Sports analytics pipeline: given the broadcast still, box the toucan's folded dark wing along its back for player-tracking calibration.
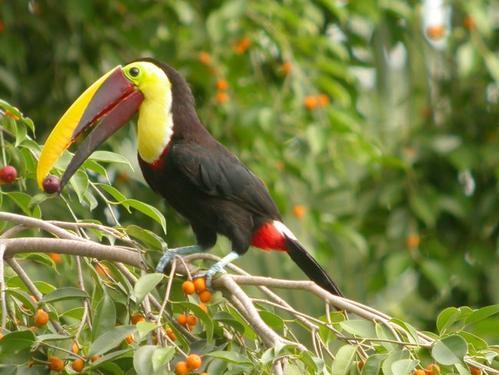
[168,142,279,219]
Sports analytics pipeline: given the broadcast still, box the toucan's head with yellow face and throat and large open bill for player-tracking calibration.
[37,59,189,189]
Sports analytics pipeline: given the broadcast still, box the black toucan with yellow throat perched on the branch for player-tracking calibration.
[37,58,342,296]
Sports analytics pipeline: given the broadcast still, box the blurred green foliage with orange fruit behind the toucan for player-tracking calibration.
[0,0,499,339]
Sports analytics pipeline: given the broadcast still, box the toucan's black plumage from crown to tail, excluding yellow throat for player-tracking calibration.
[139,59,341,295]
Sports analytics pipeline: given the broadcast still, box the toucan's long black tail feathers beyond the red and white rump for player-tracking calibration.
[286,236,343,297]
